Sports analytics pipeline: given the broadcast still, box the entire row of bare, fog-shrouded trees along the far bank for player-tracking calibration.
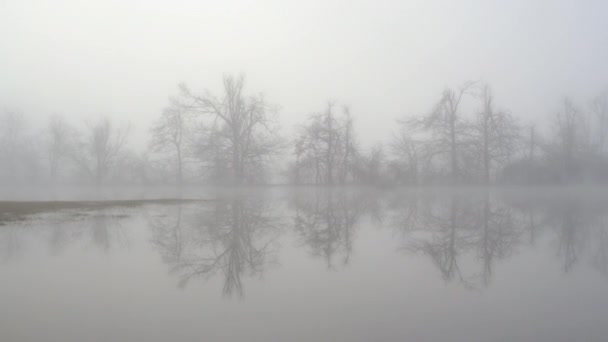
[0,75,608,186]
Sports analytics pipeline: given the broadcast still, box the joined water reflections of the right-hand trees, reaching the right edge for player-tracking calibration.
[389,192,608,289]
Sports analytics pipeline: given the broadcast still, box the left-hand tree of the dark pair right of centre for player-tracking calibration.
[409,82,473,182]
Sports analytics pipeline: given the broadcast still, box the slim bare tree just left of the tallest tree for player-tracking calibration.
[150,99,191,185]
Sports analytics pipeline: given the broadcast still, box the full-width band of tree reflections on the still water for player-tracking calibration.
[0,189,608,296]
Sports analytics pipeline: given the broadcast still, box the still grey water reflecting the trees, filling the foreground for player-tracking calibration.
[0,189,608,341]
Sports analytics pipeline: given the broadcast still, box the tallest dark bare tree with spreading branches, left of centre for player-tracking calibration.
[180,75,282,184]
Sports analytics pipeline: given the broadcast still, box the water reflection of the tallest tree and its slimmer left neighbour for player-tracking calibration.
[151,198,280,296]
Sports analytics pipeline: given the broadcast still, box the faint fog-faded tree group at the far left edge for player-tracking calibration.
[0,110,134,185]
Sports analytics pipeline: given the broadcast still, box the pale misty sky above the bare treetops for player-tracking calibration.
[0,0,608,146]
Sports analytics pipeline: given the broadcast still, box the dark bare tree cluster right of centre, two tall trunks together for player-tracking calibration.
[389,83,519,184]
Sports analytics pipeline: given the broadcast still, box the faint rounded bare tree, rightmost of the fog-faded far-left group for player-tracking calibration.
[73,117,130,184]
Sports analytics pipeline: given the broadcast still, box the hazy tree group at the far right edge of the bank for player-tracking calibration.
[502,92,608,184]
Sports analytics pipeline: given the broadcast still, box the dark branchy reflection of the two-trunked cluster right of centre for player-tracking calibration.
[405,196,520,289]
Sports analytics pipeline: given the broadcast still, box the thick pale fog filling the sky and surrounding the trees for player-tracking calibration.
[0,1,608,184]
